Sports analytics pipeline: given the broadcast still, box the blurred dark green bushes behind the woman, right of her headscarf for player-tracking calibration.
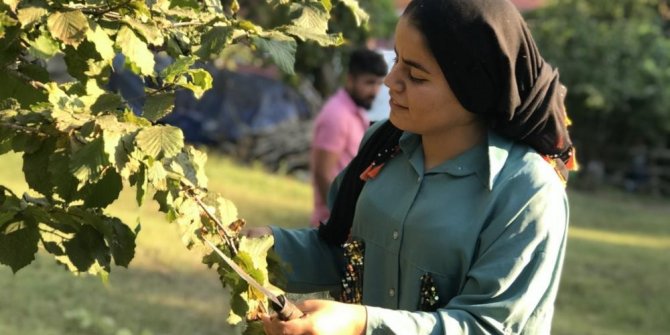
[528,0,670,158]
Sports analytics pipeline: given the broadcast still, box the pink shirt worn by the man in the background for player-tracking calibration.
[310,89,370,227]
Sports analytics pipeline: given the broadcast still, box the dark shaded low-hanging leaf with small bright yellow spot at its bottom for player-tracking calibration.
[63,225,111,272]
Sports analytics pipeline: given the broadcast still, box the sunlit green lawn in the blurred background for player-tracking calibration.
[0,155,670,335]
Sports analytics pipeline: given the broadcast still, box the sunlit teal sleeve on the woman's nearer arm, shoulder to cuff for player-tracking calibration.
[366,180,568,335]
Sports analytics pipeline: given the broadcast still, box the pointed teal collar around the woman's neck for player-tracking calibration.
[399,131,514,190]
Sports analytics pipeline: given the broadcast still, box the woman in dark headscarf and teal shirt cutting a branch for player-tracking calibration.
[252,0,573,334]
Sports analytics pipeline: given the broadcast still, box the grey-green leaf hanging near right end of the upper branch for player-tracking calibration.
[252,32,297,74]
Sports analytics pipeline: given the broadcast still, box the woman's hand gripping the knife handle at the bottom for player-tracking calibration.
[261,300,367,335]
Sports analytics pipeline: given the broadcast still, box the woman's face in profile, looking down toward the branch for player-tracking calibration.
[384,17,478,136]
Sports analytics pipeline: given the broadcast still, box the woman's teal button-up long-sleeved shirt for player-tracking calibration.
[273,124,568,334]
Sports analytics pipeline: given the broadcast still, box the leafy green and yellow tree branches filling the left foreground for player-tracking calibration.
[0,0,365,332]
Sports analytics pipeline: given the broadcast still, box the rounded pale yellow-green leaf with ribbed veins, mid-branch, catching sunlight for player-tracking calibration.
[135,125,184,159]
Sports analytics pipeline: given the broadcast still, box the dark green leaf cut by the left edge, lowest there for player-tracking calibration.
[0,220,40,273]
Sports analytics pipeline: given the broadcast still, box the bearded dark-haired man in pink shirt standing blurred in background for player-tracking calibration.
[310,49,387,227]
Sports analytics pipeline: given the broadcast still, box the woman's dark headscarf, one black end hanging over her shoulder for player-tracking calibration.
[319,0,576,245]
